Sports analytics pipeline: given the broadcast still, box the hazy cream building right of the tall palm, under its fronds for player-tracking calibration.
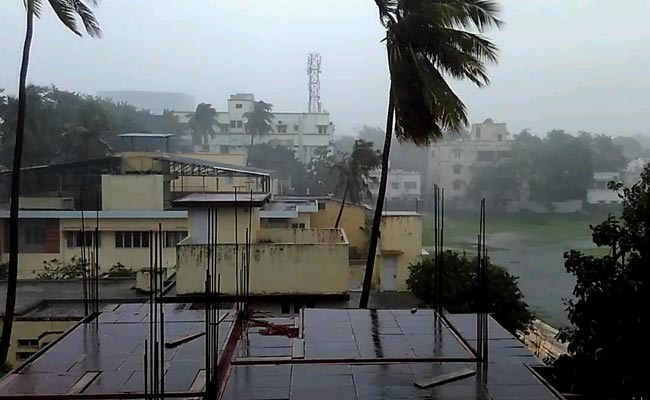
[429,119,513,206]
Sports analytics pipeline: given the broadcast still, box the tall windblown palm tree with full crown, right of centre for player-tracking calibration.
[359,0,501,307]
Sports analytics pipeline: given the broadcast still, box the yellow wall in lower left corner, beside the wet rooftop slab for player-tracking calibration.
[0,319,77,368]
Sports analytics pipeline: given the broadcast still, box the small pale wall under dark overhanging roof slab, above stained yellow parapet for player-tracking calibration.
[188,207,260,244]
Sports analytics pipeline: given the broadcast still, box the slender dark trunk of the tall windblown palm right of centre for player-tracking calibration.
[359,85,395,308]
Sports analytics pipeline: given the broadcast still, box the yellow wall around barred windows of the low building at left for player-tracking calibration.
[0,216,188,279]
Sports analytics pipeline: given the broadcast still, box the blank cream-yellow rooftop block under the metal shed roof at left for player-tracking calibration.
[102,175,165,211]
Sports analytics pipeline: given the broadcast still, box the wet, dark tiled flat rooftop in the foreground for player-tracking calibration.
[0,303,558,400]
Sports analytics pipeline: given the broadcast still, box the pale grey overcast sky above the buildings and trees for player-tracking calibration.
[0,0,650,135]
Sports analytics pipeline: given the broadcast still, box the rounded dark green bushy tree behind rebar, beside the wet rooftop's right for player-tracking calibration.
[406,250,534,335]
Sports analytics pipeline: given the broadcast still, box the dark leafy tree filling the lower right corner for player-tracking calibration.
[553,166,650,399]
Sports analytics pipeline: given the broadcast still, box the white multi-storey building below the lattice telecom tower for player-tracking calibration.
[175,93,334,163]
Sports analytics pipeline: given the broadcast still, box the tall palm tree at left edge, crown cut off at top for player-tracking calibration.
[0,0,101,365]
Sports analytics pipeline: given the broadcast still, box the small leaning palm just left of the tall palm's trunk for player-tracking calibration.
[334,139,381,228]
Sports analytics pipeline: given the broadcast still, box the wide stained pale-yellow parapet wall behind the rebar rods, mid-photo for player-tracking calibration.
[176,244,349,295]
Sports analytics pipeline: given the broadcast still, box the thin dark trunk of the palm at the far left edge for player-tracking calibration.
[0,0,34,367]
